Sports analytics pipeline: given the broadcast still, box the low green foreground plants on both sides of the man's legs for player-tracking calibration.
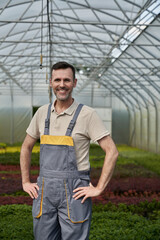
[0,201,160,240]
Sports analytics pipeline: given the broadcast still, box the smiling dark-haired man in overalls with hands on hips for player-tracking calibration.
[20,62,118,240]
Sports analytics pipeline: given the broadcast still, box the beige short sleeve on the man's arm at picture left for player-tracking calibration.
[26,110,40,139]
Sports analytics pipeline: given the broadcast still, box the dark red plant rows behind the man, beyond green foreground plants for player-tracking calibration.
[0,165,160,205]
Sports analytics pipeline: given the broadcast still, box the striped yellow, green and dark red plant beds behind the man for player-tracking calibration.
[0,145,160,205]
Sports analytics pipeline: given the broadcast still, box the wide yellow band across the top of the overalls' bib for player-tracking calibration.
[41,135,74,146]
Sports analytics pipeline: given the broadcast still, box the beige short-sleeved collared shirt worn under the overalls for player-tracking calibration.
[26,101,109,170]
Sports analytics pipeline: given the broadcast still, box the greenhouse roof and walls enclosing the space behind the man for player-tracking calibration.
[0,0,160,153]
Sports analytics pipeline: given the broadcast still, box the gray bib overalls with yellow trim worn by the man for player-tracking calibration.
[32,104,92,240]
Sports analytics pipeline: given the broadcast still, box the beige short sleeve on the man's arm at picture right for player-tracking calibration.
[88,110,110,142]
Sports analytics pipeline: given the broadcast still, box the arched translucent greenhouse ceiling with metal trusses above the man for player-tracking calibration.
[0,0,160,108]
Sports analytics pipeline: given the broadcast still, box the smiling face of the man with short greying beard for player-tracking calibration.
[50,68,77,101]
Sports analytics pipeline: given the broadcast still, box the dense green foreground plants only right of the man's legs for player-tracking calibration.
[90,207,160,240]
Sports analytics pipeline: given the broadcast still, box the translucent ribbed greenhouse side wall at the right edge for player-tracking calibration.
[130,103,160,153]
